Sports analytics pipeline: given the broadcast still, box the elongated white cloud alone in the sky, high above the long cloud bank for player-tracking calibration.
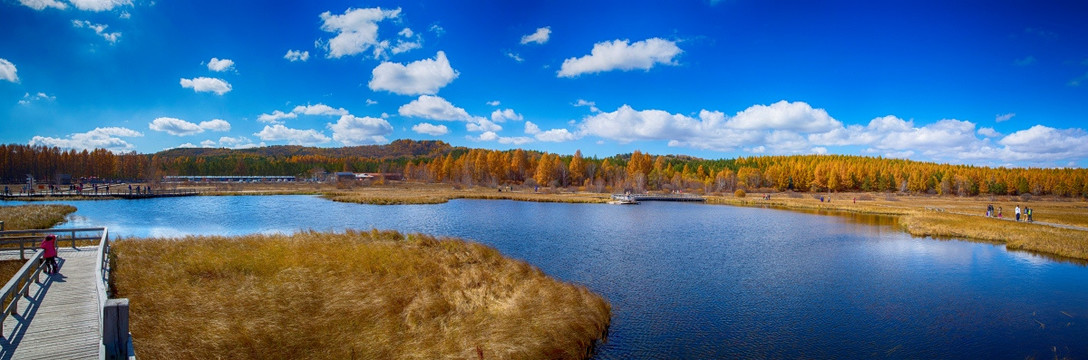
[558,37,682,77]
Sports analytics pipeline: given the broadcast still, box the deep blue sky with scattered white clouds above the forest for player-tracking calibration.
[0,0,1088,167]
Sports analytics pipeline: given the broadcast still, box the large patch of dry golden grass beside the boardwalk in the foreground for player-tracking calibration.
[111,231,611,359]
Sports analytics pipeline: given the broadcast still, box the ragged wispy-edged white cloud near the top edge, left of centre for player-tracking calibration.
[321,8,400,59]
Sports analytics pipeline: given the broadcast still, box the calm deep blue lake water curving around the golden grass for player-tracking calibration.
[4,196,1088,359]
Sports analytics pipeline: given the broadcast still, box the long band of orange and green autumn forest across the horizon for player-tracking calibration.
[0,140,1088,198]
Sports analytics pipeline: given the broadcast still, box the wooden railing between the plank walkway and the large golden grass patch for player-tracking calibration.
[95,227,136,360]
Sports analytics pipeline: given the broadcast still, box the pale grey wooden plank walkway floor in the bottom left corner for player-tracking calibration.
[0,246,101,359]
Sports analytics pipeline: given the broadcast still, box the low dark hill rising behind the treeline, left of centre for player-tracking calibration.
[154,139,454,160]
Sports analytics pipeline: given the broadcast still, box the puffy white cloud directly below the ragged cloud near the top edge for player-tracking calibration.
[368,51,459,95]
